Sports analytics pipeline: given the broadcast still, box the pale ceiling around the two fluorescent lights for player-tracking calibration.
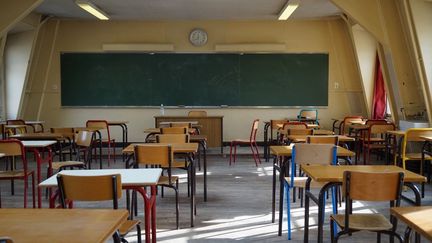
[35,0,341,20]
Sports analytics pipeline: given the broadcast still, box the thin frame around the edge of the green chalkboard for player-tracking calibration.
[60,51,330,109]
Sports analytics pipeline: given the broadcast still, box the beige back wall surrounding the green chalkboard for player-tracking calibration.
[23,19,366,141]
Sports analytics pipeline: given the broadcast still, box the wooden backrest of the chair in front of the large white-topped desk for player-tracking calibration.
[57,174,122,204]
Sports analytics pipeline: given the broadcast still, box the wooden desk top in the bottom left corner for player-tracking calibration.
[0,208,129,243]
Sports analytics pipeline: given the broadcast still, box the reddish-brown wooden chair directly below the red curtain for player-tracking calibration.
[361,122,396,164]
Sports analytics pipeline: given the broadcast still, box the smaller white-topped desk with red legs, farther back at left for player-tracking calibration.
[22,140,57,208]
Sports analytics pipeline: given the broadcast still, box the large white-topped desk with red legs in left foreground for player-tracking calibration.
[39,169,162,243]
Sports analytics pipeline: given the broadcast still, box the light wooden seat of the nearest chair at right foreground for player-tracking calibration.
[331,214,393,231]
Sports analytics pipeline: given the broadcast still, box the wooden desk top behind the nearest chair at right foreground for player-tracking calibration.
[301,164,426,182]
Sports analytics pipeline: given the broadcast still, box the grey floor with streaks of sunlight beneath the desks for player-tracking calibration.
[0,145,432,242]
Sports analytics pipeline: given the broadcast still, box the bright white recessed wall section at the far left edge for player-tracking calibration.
[5,31,34,119]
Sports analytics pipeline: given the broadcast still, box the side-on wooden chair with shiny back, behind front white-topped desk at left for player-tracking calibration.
[52,131,93,171]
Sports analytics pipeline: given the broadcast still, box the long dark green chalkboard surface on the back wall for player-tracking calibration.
[60,53,328,107]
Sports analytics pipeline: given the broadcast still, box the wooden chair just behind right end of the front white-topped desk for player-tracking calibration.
[134,144,179,229]
